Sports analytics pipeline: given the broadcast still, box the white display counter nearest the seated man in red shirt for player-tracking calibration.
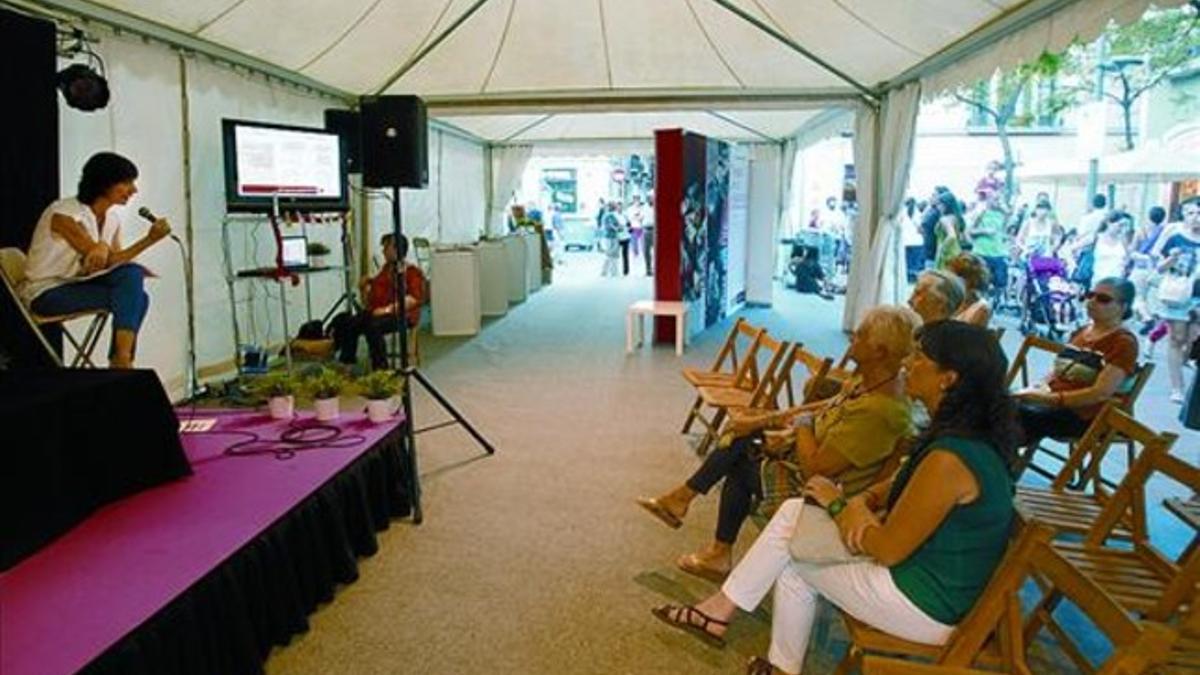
[430,247,482,335]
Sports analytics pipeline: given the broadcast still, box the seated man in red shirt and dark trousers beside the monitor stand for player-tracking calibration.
[334,234,425,370]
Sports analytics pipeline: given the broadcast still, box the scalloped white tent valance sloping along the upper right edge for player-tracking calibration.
[922,0,1156,98]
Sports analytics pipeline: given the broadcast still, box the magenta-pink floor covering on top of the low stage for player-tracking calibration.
[0,410,396,675]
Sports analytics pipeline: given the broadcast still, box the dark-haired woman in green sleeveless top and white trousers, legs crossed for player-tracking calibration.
[654,321,1018,675]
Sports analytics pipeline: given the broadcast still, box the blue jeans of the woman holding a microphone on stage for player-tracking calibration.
[30,264,150,333]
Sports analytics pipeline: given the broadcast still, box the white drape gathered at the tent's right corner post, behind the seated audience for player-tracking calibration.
[842,83,920,330]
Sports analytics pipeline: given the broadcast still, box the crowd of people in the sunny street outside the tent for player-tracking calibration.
[901,183,1200,404]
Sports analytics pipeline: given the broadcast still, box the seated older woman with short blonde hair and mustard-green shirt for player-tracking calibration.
[638,306,920,580]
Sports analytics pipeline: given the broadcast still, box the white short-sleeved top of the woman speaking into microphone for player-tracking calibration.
[20,197,121,303]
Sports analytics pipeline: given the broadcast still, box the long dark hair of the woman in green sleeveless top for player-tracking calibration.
[916,321,1020,468]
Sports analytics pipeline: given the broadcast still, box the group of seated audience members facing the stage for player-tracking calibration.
[637,237,1185,675]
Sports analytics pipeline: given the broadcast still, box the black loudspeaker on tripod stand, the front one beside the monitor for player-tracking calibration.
[360,96,430,187]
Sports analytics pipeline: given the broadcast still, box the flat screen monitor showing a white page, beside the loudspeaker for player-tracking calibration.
[221,119,349,211]
